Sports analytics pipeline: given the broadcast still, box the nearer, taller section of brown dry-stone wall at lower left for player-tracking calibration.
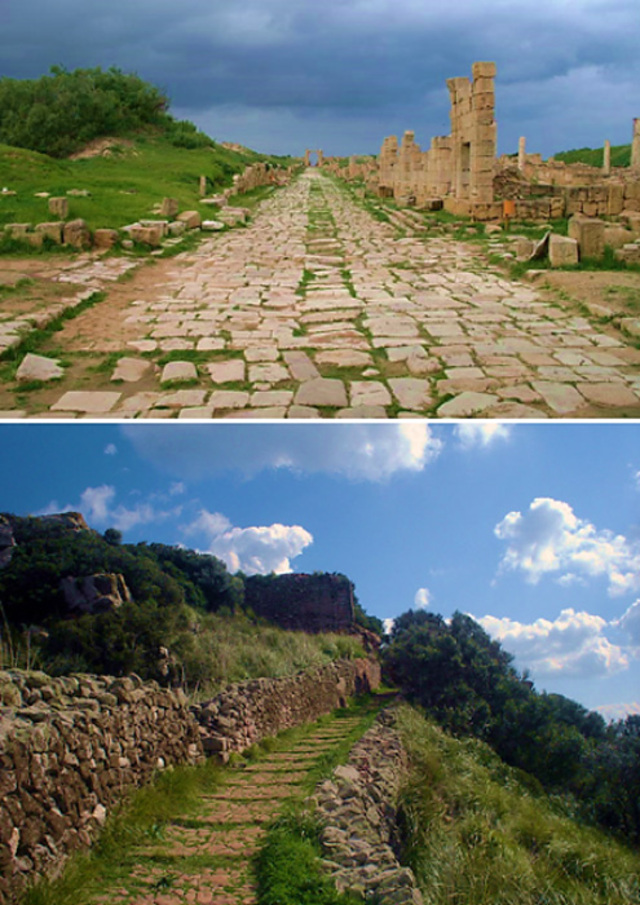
[0,670,203,903]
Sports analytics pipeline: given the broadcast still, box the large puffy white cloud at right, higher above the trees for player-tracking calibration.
[494,497,640,595]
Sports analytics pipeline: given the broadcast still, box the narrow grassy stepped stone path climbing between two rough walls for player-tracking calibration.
[87,716,361,905]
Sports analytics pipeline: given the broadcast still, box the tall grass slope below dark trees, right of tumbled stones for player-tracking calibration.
[399,707,640,905]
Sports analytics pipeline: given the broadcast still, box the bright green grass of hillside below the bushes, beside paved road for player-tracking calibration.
[0,133,292,229]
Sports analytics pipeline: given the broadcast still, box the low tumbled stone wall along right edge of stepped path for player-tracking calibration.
[315,710,423,905]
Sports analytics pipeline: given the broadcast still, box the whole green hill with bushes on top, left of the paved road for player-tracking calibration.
[0,67,290,237]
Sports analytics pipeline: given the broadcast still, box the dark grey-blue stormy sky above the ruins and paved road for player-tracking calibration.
[0,0,640,157]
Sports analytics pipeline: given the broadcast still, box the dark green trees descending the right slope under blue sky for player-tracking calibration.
[383,611,640,844]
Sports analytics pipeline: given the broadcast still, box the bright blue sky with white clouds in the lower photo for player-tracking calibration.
[0,422,640,716]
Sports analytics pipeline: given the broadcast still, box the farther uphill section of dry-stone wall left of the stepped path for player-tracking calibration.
[193,659,380,762]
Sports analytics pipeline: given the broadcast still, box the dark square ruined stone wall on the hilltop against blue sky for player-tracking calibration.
[245,573,355,633]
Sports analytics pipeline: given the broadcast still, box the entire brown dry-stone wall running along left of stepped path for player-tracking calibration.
[0,659,380,905]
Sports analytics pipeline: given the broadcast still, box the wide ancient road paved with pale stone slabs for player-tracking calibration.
[5,170,640,419]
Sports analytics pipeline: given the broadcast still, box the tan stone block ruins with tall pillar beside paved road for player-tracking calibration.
[332,62,640,221]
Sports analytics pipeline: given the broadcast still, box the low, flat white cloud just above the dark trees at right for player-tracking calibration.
[477,609,629,678]
